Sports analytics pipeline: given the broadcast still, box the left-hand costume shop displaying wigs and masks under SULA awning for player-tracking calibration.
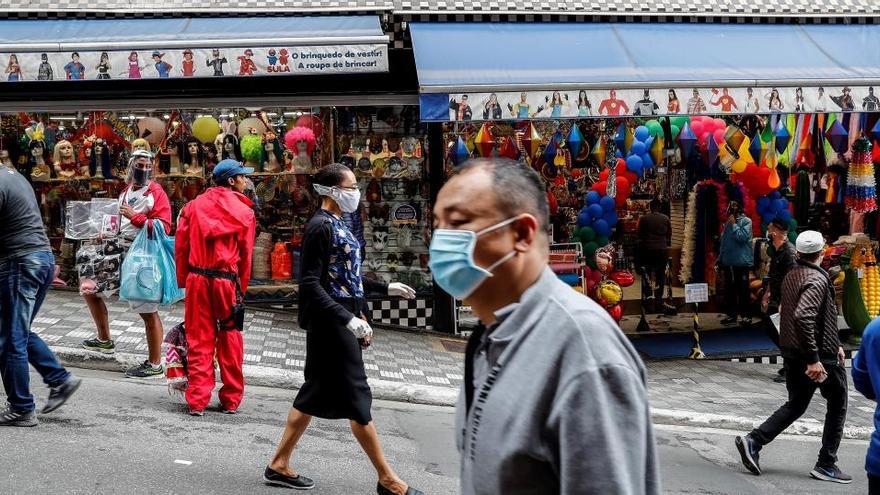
[0,15,432,329]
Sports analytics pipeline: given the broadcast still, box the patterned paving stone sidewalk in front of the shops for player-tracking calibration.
[34,291,874,438]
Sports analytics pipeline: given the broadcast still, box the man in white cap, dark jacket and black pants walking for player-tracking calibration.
[735,230,852,484]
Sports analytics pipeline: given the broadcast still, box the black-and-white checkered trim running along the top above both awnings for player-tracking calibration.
[0,0,880,22]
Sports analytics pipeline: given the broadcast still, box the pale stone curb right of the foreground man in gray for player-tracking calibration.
[651,409,874,440]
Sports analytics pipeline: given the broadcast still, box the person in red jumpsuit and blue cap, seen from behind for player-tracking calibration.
[175,159,256,416]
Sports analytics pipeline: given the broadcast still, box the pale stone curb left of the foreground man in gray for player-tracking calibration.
[51,346,458,406]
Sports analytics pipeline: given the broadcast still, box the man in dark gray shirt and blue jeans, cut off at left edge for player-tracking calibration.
[0,167,82,426]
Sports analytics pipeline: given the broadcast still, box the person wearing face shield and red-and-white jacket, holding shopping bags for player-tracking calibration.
[82,150,171,378]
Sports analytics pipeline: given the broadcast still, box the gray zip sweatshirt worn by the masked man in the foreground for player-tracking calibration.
[456,268,660,495]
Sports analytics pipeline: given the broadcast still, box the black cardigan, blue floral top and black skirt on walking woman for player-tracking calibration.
[293,210,388,425]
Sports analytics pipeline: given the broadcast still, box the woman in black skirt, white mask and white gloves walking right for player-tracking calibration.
[263,163,422,495]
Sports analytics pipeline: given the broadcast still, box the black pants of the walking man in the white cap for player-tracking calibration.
[750,359,847,466]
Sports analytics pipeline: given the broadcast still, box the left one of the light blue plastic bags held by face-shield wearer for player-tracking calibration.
[119,224,163,303]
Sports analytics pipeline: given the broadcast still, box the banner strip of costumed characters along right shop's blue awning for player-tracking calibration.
[438,86,880,122]
